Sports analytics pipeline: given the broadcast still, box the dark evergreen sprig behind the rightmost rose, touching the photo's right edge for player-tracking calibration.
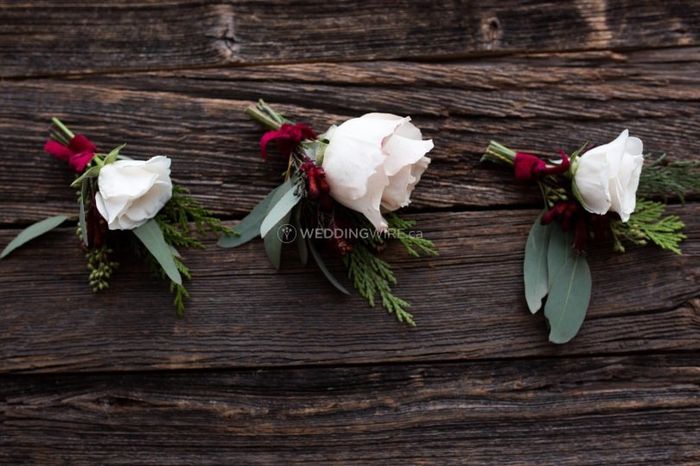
[637,154,700,202]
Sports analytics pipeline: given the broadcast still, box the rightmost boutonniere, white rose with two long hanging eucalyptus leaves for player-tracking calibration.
[482,130,700,343]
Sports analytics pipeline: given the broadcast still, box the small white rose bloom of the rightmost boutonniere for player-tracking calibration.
[574,130,644,222]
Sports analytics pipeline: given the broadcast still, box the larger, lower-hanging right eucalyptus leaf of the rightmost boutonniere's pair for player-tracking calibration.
[544,228,591,343]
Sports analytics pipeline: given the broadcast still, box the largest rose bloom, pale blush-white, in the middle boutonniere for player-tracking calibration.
[323,113,433,231]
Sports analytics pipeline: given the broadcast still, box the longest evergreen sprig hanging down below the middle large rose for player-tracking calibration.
[343,243,416,326]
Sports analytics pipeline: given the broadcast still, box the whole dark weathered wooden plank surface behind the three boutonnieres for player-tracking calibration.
[0,0,700,465]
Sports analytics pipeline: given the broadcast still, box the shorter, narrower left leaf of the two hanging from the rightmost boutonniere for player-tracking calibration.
[523,215,554,314]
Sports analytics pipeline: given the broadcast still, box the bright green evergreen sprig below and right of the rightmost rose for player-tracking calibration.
[610,200,686,255]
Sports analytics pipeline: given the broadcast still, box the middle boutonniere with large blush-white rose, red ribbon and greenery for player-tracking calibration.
[219,100,437,325]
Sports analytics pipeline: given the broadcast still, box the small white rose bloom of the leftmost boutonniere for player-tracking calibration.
[95,155,173,230]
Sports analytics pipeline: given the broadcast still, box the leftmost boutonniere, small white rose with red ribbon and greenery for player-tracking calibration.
[0,118,232,315]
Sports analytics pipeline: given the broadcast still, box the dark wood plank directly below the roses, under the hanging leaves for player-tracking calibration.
[0,204,700,372]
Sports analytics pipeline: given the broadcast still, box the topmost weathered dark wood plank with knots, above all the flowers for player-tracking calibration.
[0,0,700,77]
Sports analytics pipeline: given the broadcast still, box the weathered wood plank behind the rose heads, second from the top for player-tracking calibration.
[0,49,700,223]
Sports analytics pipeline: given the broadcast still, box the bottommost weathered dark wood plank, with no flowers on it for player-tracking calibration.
[0,354,700,466]
